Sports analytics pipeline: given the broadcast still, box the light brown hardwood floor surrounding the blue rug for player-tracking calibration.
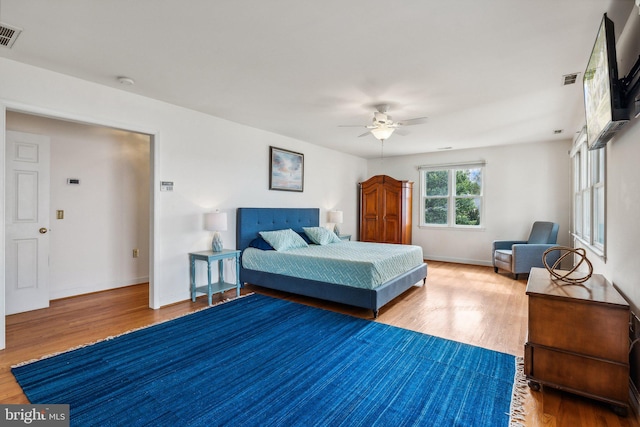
[0,261,640,427]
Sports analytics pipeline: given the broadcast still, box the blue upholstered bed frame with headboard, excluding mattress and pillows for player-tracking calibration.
[236,208,427,318]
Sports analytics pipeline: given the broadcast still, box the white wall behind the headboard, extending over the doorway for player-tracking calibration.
[0,58,367,344]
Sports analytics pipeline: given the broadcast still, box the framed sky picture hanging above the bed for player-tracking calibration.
[269,147,304,192]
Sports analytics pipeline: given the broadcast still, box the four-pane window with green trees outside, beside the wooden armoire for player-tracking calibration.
[419,163,484,228]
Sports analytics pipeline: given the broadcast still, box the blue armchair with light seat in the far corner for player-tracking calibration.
[492,221,560,280]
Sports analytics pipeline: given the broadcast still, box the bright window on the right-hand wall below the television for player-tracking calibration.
[571,133,606,256]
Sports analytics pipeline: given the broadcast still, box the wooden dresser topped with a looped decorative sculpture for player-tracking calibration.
[524,268,629,415]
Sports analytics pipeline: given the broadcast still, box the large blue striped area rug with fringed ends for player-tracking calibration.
[12,294,516,427]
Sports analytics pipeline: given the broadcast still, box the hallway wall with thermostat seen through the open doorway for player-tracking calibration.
[7,112,150,299]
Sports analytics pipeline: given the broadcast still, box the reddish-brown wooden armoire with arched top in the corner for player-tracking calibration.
[359,175,413,245]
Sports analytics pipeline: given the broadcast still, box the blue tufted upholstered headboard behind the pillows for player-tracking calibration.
[236,208,320,250]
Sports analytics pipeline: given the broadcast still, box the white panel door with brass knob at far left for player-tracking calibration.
[5,131,49,314]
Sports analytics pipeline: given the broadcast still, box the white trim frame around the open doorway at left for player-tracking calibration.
[0,99,160,350]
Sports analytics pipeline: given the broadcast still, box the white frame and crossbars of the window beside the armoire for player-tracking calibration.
[418,161,486,230]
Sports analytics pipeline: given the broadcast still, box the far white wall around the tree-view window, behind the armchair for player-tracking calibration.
[369,140,571,265]
